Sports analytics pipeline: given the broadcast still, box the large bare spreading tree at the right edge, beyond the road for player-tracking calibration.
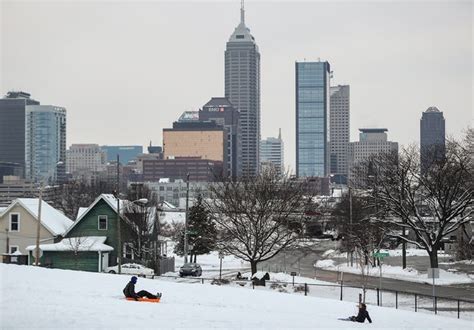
[361,142,474,268]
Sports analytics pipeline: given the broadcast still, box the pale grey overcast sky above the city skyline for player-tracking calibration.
[0,0,474,169]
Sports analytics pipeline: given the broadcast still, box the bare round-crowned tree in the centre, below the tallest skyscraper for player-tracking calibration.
[204,168,311,274]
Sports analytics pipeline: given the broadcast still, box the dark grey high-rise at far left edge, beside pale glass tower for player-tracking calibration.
[0,92,40,177]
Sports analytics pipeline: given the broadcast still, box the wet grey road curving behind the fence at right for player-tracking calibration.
[258,240,474,301]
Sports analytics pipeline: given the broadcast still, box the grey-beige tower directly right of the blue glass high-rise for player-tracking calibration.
[329,85,350,184]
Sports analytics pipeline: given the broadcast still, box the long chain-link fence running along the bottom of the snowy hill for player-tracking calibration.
[153,276,474,320]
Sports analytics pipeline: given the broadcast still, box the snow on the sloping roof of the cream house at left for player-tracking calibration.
[5,198,74,235]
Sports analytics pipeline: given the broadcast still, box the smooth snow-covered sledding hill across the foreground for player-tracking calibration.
[0,264,472,329]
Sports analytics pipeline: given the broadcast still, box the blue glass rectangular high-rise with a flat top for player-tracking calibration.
[295,61,331,177]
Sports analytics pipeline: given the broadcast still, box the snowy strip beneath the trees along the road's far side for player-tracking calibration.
[314,259,474,285]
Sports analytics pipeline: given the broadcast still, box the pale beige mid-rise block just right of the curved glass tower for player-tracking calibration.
[66,144,107,177]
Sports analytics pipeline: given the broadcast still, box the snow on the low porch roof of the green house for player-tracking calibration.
[26,236,114,252]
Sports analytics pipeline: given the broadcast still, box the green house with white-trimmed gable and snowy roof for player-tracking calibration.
[27,194,141,272]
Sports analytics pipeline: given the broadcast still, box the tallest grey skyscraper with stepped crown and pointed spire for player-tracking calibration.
[225,0,260,176]
